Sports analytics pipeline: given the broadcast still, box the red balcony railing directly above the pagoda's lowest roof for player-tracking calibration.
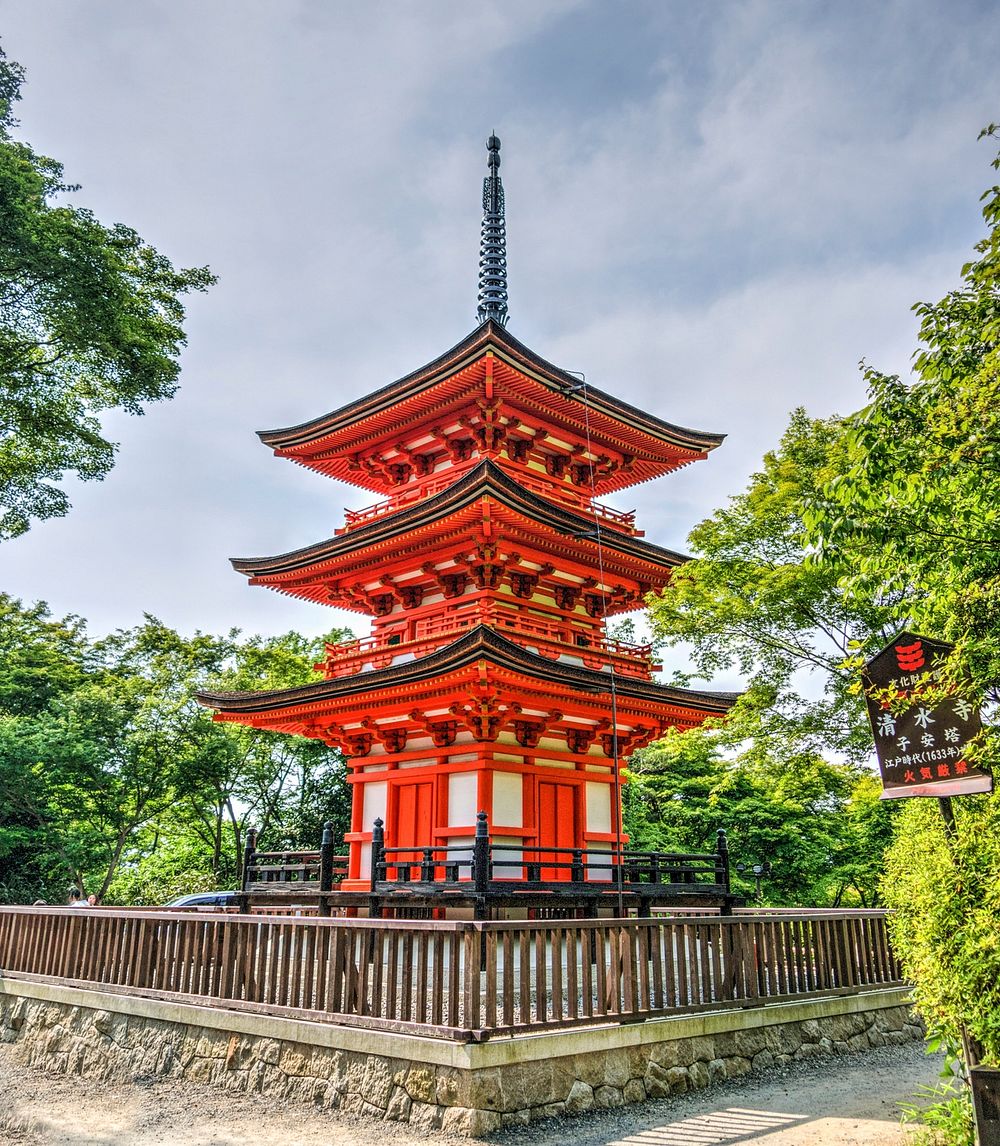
[314,611,662,681]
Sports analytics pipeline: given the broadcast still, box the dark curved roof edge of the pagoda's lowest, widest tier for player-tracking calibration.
[195,625,740,716]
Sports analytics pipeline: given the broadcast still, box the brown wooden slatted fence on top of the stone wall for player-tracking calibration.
[0,906,901,1042]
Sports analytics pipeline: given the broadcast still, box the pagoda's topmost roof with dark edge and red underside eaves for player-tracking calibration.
[258,319,725,488]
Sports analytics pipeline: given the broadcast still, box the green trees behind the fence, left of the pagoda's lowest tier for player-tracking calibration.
[0,596,349,902]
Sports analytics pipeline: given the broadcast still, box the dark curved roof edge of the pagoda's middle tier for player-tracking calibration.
[230,460,687,599]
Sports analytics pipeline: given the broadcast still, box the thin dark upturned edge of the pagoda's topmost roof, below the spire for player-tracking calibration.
[258,319,726,453]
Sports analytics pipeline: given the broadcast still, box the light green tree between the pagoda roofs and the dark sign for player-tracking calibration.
[651,409,891,761]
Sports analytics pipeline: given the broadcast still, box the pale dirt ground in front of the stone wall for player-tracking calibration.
[0,1044,940,1146]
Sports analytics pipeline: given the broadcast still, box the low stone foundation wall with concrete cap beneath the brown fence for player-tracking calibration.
[0,980,923,1137]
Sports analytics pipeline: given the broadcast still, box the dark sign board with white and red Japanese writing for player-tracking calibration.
[864,633,993,800]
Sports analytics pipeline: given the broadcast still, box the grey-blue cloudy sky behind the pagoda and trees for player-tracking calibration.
[0,0,1000,664]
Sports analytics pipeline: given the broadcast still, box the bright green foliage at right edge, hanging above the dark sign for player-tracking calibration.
[805,128,1000,698]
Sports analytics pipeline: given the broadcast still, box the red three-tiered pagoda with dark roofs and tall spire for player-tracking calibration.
[199,135,735,890]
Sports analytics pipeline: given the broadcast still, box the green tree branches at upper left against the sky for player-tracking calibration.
[0,52,215,539]
